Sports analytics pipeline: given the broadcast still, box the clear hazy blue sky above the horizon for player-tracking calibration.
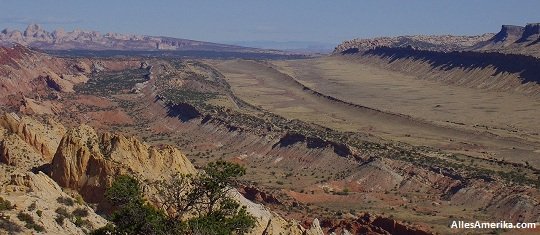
[0,0,540,43]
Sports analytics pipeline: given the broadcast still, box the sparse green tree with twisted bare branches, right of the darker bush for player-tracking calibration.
[159,161,255,234]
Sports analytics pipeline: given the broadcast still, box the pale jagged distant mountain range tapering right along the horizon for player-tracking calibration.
[0,24,282,53]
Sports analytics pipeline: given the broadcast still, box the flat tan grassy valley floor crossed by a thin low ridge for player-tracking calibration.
[210,57,540,168]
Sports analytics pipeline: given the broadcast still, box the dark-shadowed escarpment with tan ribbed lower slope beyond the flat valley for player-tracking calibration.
[344,47,540,96]
